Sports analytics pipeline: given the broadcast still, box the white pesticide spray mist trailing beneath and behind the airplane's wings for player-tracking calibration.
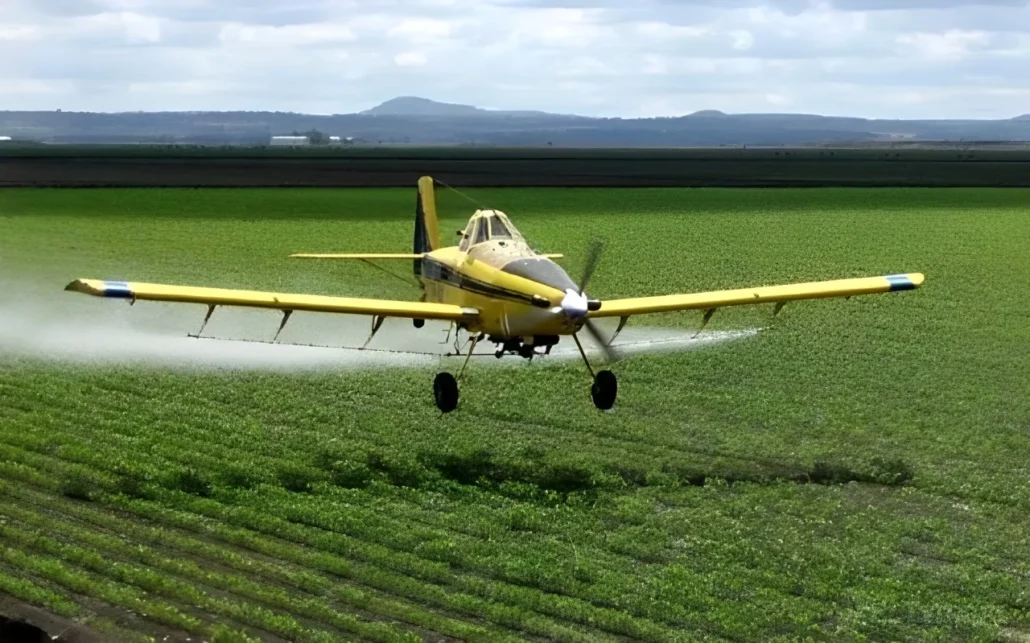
[0,284,759,372]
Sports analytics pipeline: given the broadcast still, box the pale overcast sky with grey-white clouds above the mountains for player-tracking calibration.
[0,0,1030,119]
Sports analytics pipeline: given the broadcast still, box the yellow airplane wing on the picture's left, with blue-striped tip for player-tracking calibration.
[65,279,479,322]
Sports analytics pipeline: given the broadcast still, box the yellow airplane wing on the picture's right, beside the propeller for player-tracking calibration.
[588,272,925,317]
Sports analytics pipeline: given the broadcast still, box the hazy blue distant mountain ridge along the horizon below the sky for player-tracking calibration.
[0,96,1030,147]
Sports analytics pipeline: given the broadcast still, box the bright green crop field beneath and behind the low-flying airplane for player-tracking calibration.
[0,189,1030,641]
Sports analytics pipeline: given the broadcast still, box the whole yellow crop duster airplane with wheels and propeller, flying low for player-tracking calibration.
[65,176,924,412]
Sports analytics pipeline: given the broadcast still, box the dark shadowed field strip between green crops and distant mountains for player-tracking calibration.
[6,145,1030,188]
